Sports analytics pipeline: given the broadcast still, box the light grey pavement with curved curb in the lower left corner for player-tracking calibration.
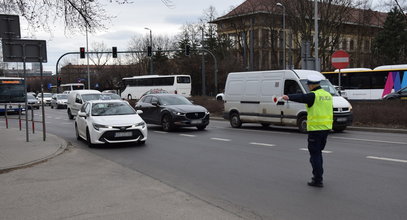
[0,128,244,220]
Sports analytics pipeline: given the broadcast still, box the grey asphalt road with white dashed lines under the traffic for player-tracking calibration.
[3,108,407,219]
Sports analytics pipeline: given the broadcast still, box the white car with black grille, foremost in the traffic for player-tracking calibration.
[75,100,147,147]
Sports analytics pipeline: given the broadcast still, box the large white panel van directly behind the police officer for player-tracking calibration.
[223,70,353,132]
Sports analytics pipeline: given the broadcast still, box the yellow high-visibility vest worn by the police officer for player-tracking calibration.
[307,89,333,131]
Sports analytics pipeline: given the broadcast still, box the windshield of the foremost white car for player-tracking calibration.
[92,102,136,116]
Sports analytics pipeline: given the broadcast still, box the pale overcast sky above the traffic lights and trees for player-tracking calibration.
[10,0,244,73]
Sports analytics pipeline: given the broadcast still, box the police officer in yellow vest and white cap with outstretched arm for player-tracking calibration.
[281,75,333,187]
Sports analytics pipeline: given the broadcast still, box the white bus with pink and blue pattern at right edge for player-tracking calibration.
[323,65,407,100]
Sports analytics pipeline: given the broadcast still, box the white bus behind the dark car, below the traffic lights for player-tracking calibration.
[121,75,191,100]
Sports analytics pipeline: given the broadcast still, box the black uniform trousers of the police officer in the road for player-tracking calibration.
[308,130,329,182]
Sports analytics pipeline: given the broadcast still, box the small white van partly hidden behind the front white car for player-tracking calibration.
[67,90,102,119]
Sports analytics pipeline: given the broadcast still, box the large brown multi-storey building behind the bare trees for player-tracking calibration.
[211,0,387,70]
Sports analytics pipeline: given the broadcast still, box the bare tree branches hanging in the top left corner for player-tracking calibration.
[0,0,173,32]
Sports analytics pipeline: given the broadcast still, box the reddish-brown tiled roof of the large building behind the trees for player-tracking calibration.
[212,0,387,27]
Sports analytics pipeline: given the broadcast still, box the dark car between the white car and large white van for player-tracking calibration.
[136,94,209,131]
